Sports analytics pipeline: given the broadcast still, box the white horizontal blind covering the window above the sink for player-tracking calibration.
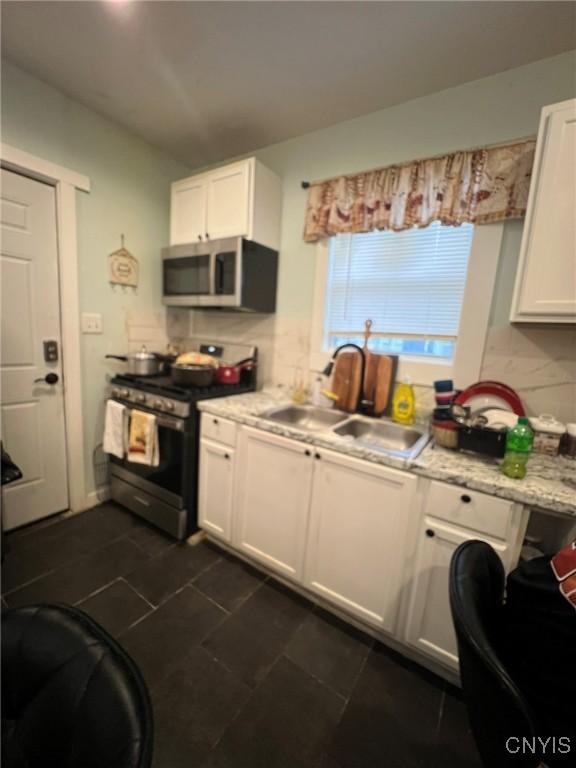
[324,222,474,359]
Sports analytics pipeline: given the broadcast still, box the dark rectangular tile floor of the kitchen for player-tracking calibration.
[2,504,480,768]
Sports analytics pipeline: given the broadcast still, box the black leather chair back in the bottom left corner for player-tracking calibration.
[2,604,153,768]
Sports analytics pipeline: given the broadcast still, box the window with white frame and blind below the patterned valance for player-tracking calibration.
[311,222,503,387]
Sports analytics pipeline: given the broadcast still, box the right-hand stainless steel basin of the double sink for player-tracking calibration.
[332,416,430,459]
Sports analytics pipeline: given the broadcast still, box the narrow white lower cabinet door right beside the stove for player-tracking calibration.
[198,440,234,542]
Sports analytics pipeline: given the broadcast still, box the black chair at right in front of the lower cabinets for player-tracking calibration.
[450,541,540,768]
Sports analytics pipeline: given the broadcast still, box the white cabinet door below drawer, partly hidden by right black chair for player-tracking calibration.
[406,517,508,670]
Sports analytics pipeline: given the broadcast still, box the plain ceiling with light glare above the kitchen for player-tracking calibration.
[2,0,576,167]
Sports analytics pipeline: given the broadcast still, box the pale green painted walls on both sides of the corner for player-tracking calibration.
[2,52,576,498]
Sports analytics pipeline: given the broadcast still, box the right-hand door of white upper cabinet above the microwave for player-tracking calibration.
[206,161,251,240]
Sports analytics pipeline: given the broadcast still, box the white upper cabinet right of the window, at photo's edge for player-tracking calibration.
[510,99,576,323]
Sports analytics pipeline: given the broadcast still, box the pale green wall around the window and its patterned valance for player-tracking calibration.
[244,51,576,323]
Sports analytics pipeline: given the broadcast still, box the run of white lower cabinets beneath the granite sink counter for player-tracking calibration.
[199,414,528,670]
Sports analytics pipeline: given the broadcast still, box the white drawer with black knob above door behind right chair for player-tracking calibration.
[426,481,514,539]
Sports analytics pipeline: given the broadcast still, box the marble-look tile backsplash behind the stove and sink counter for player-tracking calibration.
[164,309,576,422]
